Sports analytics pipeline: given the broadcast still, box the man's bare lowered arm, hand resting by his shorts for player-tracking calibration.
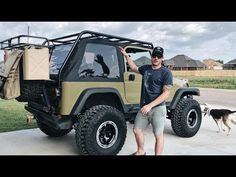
[141,85,172,114]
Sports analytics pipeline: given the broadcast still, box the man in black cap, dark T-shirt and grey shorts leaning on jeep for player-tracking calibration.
[120,47,173,155]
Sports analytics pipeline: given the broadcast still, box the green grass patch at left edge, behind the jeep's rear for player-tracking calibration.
[0,99,37,132]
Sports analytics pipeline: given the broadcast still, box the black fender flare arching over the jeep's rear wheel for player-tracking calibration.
[71,87,126,115]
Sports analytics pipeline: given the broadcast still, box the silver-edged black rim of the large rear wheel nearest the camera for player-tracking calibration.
[96,121,118,148]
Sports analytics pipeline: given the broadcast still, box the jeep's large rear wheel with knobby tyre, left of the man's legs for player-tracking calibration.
[75,105,127,155]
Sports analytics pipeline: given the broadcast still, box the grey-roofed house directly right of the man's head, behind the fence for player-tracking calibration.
[164,55,207,70]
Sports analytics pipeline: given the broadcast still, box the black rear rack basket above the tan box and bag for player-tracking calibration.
[0,35,49,50]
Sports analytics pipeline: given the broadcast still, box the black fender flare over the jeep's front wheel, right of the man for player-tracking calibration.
[169,87,200,109]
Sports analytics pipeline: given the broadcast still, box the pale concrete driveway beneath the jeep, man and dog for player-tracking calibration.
[0,89,236,155]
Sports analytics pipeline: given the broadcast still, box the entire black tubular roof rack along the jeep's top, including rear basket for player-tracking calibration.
[0,30,153,50]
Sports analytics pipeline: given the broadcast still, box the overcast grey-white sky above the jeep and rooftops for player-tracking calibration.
[0,22,236,63]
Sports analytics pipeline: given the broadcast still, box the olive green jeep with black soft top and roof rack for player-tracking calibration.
[0,31,202,155]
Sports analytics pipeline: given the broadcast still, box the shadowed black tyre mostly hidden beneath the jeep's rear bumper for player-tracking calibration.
[36,119,72,137]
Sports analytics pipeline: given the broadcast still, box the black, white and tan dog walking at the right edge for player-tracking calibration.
[203,103,236,135]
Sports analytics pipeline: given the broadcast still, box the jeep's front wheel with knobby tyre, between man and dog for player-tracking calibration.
[171,98,202,137]
